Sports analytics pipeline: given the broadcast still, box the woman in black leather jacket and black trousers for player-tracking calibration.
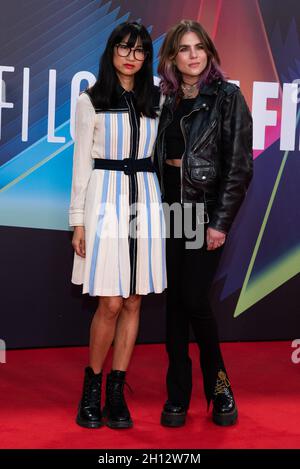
[155,20,252,427]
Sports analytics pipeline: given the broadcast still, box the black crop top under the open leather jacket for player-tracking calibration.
[165,98,196,160]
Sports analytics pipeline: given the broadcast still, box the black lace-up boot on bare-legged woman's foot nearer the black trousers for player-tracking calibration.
[103,370,133,428]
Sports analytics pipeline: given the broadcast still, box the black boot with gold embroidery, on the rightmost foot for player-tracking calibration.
[212,370,238,427]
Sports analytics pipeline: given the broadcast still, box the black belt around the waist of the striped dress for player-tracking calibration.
[94,157,155,176]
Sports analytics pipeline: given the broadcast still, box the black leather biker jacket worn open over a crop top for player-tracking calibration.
[154,80,253,233]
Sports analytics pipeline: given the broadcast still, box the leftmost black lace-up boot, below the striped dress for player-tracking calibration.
[76,366,103,428]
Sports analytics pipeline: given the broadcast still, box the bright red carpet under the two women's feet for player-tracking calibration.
[0,342,300,449]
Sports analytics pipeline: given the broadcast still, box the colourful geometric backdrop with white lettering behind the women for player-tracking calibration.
[0,0,300,347]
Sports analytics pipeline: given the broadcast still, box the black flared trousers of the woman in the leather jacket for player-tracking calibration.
[164,164,225,408]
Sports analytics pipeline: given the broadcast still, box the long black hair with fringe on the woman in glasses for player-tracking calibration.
[88,22,156,118]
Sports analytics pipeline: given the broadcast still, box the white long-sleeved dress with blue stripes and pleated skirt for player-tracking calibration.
[69,87,167,298]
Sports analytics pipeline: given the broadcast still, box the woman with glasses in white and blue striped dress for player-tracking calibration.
[69,23,166,428]
